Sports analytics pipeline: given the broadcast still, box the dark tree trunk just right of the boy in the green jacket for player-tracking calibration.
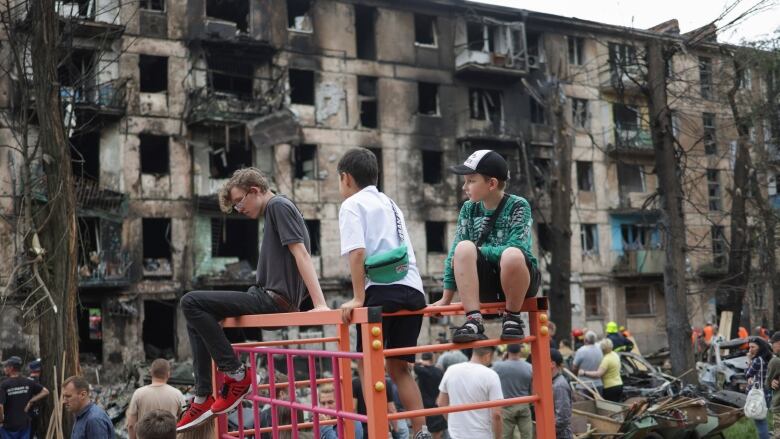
[547,83,572,339]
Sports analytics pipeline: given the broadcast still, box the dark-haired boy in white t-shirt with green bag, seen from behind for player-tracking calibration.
[338,148,431,439]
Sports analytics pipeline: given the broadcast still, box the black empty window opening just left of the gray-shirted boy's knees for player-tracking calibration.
[141,300,176,360]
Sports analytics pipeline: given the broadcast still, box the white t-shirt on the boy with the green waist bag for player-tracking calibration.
[339,186,423,293]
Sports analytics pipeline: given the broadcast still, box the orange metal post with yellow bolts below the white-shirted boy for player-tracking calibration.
[358,307,388,439]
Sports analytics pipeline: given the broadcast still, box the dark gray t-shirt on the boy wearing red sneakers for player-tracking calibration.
[256,195,311,306]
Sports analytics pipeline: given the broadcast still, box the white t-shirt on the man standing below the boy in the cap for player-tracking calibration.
[439,361,504,439]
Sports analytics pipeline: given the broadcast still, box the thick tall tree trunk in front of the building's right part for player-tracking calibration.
[647,39,698,383]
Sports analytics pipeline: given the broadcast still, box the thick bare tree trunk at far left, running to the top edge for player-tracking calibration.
[31,0,78,432]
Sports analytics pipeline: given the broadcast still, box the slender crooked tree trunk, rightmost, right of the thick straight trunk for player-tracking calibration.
[715,60,750,338]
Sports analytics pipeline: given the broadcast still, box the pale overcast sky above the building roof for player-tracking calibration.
[470,0,780,43]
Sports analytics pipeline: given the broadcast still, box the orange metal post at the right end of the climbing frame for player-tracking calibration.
[528,311,555,439]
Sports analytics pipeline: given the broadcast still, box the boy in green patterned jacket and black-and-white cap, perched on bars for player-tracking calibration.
[434,149,540,343]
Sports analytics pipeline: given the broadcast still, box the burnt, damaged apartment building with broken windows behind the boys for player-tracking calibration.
[0,0,778,371]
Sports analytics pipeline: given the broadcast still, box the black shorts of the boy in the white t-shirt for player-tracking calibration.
[356,285,426,363]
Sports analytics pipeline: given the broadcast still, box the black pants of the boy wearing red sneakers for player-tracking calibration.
[181,287,280,396]
